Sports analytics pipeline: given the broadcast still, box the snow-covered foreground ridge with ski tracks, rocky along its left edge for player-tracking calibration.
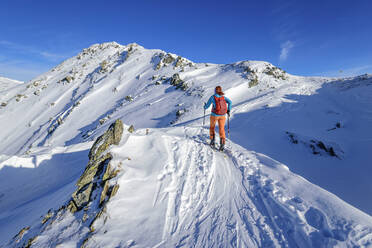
[3,121,372,247]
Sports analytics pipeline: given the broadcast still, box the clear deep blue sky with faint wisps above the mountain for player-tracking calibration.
[0,0,372,80]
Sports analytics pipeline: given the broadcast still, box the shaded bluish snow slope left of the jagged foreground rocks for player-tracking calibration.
[0,142,92,243]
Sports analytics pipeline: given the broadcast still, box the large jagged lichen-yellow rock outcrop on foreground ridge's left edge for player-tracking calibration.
[6,119,124,248]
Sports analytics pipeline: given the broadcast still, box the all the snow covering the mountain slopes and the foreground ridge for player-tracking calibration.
[0,42,372,247]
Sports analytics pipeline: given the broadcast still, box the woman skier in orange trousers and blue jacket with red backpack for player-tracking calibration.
[204,86,232,151]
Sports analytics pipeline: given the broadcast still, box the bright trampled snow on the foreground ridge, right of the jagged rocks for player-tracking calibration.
[91,128,371,247]
